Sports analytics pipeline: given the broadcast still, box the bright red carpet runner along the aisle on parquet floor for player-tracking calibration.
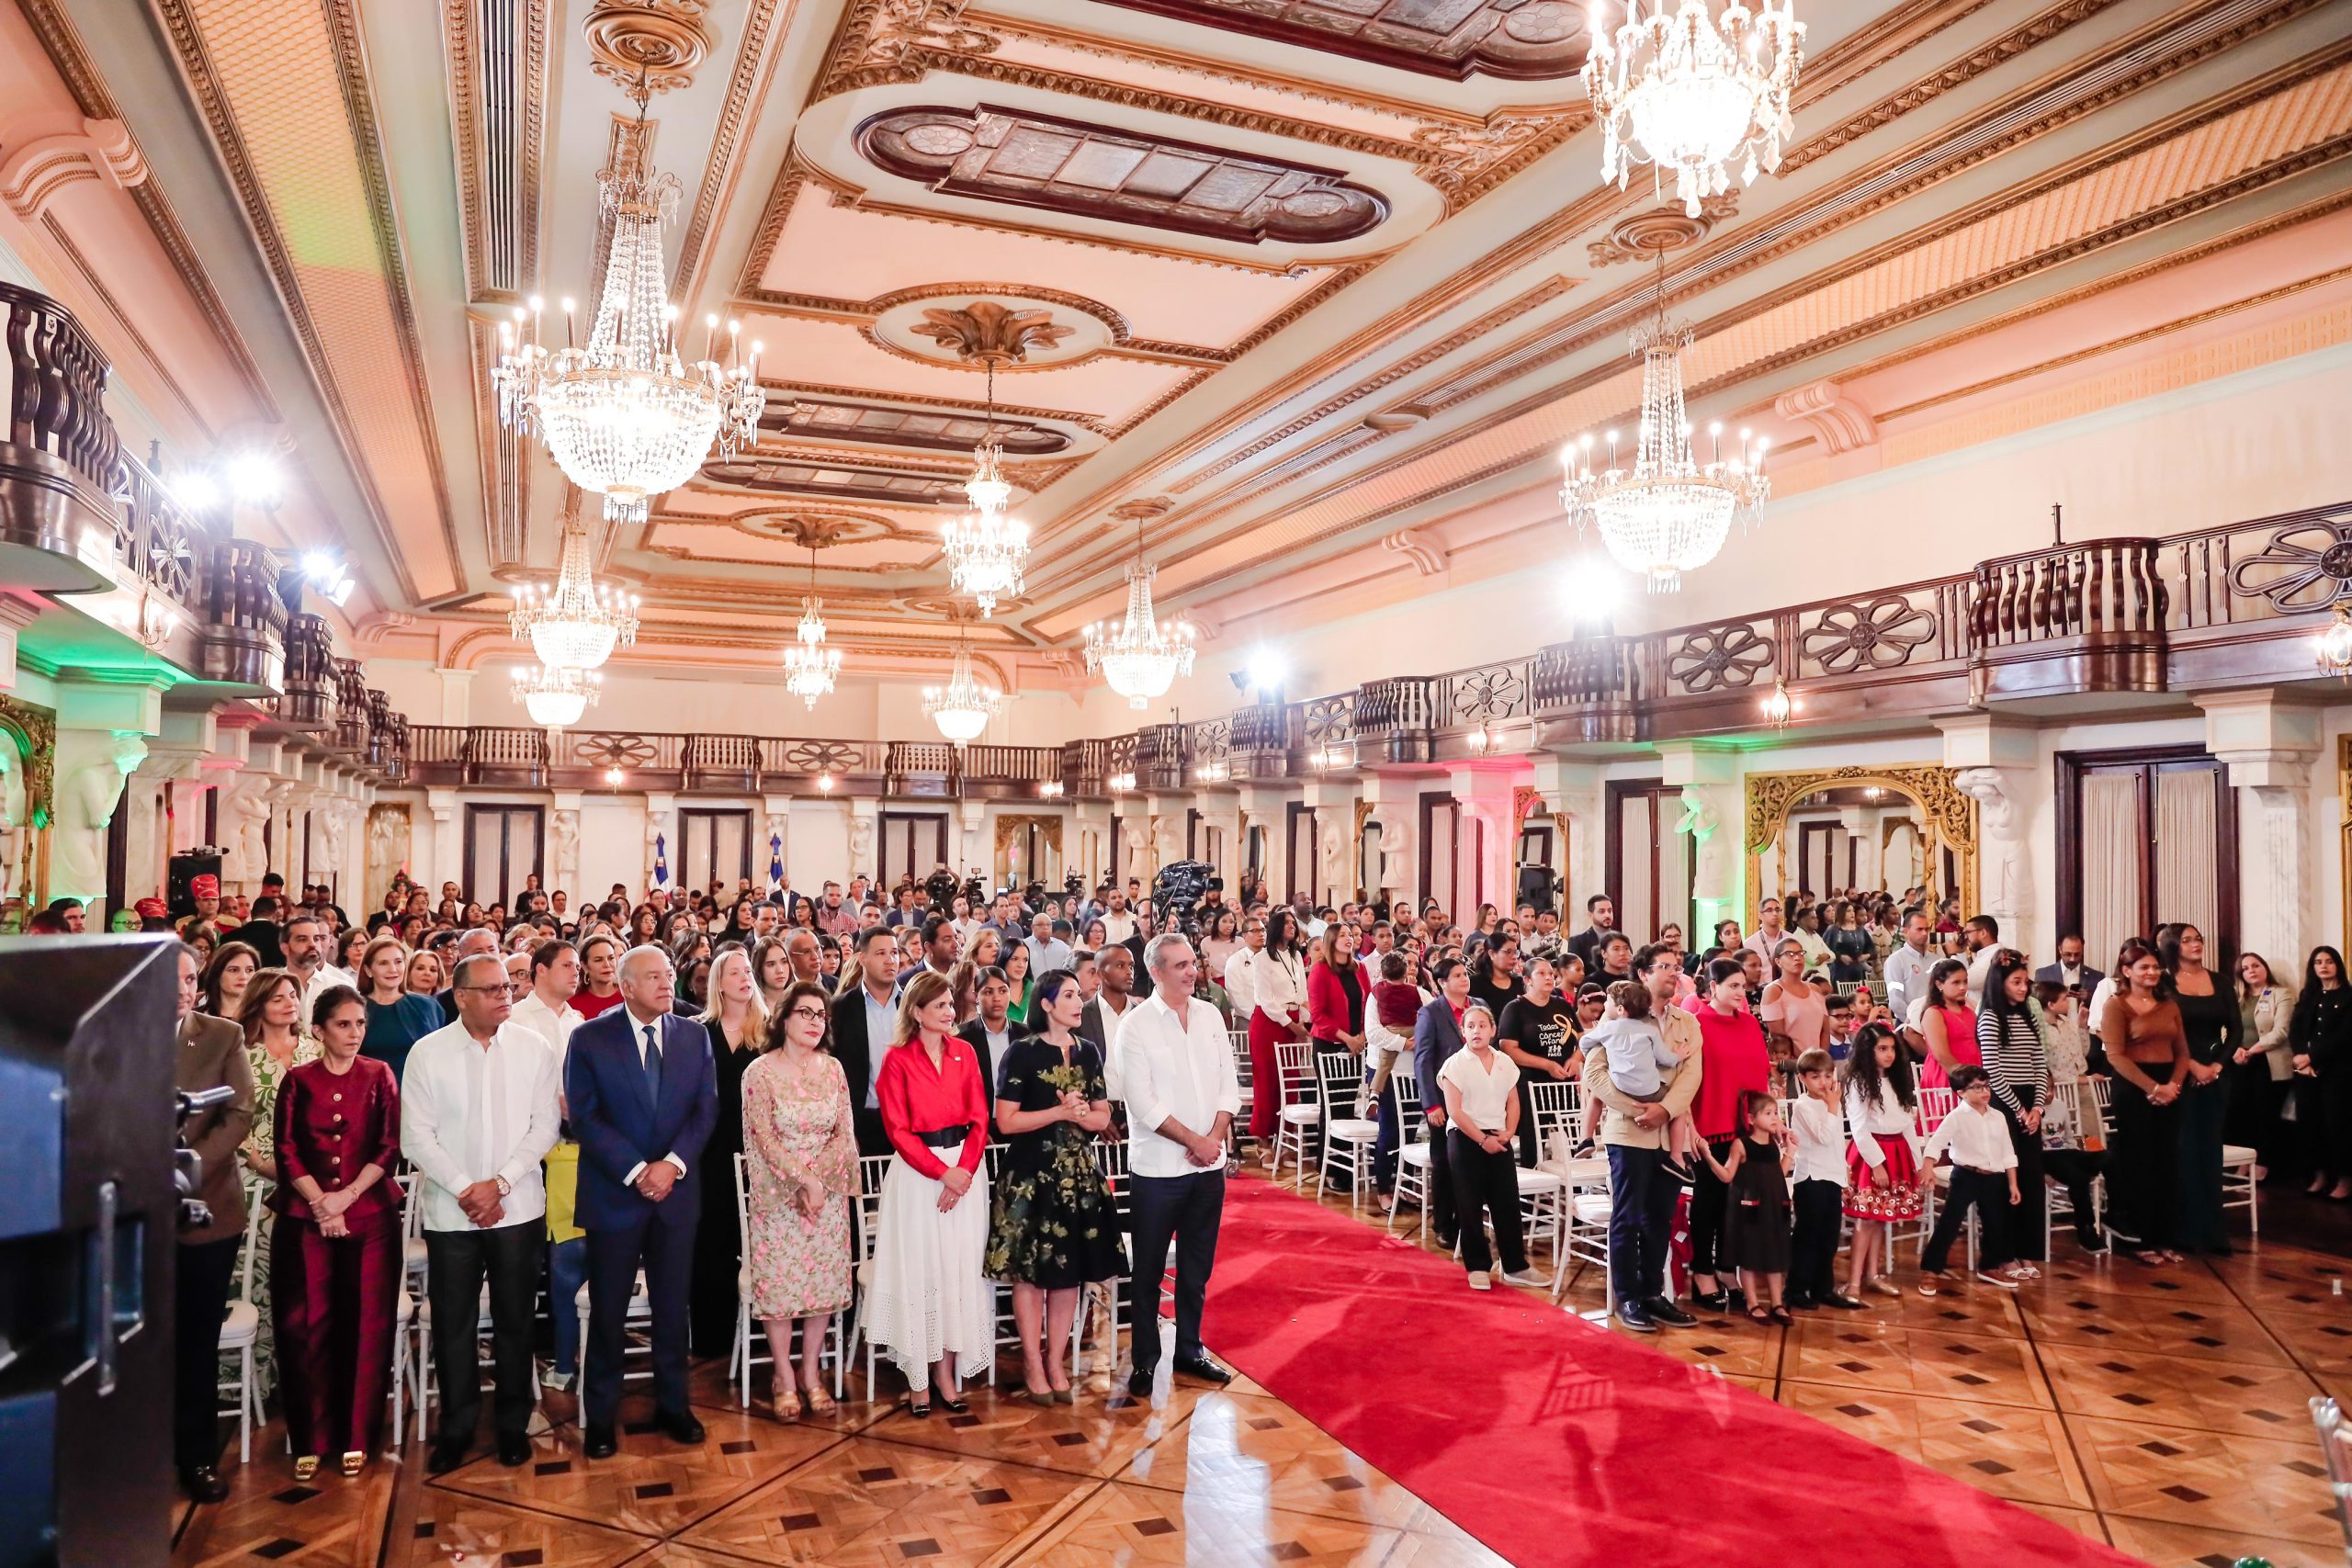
[1204,1178,2135,1568]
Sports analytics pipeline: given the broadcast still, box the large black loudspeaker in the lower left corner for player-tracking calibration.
[0,936,179,1568]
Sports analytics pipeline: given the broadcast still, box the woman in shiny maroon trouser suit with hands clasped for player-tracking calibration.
[270,985,400,1481]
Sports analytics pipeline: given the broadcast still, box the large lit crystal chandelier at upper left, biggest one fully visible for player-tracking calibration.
[492,75,767,522]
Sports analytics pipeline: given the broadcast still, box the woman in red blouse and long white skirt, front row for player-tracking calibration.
[865,971,997,1416]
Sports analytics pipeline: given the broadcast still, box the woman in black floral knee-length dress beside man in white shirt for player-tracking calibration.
[988,968,1126,1405]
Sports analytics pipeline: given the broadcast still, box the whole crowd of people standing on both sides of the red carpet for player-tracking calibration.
[143,872,2352,1497]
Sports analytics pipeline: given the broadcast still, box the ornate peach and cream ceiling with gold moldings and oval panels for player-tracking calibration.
[14,0,2352,680]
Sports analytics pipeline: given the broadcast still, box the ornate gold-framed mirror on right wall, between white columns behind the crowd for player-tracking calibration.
[1746,764,1975,931]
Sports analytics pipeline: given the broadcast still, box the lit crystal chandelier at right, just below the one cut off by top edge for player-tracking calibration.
[1559,252,1771,592]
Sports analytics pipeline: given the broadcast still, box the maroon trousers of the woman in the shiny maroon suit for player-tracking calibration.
[270,1208,404,1458]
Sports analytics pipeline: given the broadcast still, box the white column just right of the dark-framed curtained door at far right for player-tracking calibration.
[2189,691,2322,974]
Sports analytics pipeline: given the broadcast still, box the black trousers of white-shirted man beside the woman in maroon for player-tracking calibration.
[425,1220,548,1448]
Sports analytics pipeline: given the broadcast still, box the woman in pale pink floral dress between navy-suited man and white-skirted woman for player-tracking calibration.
[743,983,858,1417]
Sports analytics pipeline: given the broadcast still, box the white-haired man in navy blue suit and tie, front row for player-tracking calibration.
[564,947,719,1460]
